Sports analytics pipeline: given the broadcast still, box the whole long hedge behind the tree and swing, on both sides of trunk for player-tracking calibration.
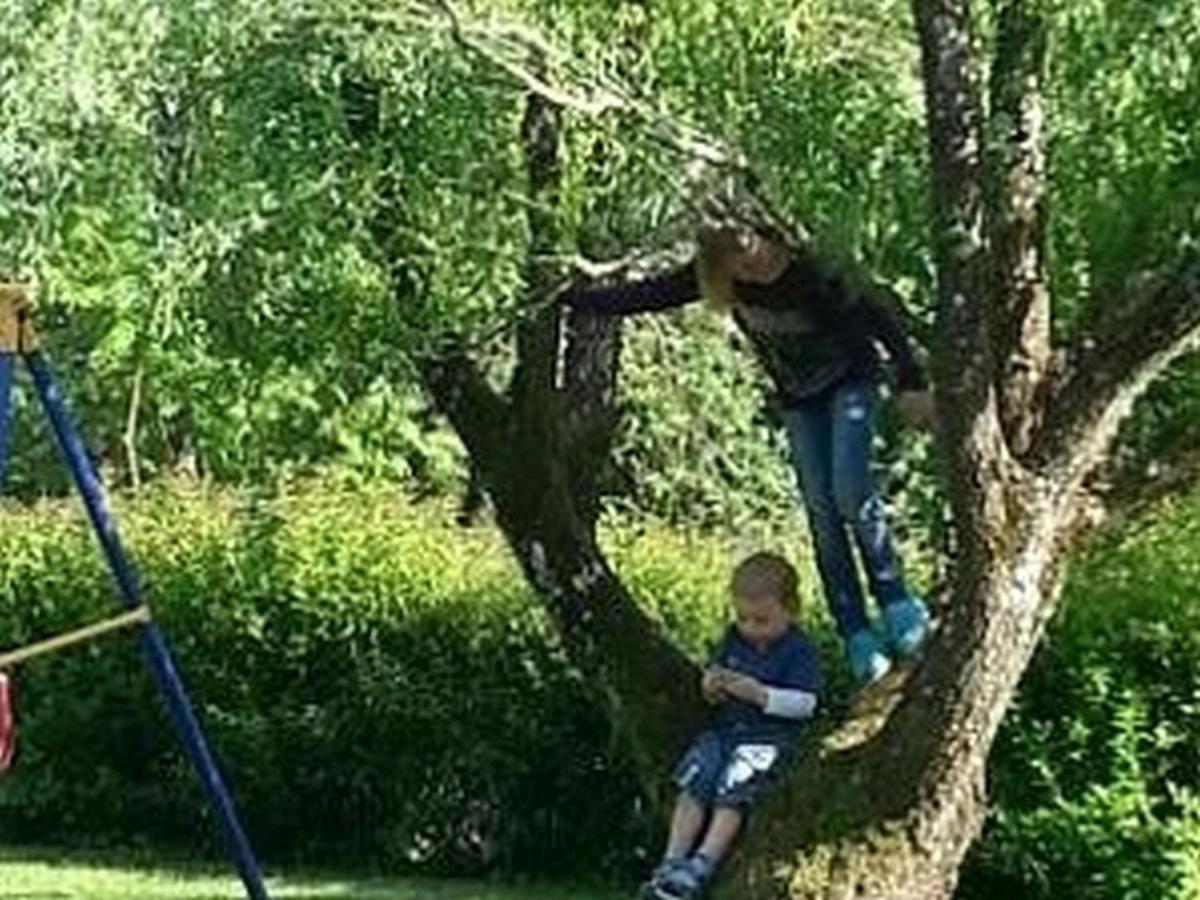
[0,486,1200,900]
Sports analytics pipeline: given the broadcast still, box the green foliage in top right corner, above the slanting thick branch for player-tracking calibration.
[1050,0,1200,314]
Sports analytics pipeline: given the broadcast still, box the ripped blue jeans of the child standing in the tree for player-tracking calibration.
[782,379,908,637]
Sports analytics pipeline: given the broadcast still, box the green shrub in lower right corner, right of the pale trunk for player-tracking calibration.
[962,498,1200,900]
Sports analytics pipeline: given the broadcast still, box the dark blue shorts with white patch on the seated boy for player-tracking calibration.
[674,728,786,809]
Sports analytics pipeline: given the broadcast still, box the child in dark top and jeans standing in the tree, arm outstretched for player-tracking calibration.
[563,224,935,684]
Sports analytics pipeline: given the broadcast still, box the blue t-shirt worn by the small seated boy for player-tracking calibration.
[710,625,821,738]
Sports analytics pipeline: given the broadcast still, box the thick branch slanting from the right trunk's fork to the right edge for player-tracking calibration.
[1032,251,1200,484]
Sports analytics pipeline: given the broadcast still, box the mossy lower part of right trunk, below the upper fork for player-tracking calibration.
[716,472,1082,900]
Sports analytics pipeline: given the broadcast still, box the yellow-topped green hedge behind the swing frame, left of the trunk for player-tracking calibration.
[0,486,768,872]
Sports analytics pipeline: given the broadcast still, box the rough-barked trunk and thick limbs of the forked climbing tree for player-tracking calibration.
[367,0,1200,900]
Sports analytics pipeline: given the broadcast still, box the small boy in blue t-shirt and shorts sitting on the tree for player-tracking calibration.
[641,553,821,900]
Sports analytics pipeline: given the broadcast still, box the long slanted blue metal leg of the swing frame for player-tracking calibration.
[25,352,269,900]
